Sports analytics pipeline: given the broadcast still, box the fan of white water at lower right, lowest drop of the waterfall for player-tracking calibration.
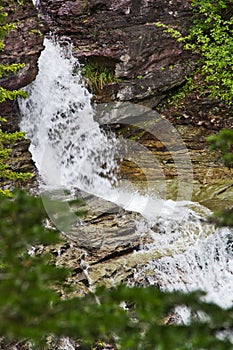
[140,224,233,308]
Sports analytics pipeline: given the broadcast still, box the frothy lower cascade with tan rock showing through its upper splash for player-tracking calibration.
[135,203,233,310]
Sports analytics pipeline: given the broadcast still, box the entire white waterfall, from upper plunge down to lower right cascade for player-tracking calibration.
[20,40,233,320]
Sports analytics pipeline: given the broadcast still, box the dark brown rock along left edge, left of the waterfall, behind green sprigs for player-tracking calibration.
[0,0,46,185]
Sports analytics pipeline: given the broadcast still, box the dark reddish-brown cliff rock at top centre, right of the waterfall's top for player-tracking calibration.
[41,0,192,107]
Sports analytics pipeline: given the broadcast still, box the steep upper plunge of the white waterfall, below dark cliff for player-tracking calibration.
[20,39,116,195]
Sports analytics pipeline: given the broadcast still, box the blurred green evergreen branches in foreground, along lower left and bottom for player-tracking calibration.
[0,191,233,350]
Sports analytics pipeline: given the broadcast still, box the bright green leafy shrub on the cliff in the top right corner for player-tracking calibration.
[156,0,233,104]
